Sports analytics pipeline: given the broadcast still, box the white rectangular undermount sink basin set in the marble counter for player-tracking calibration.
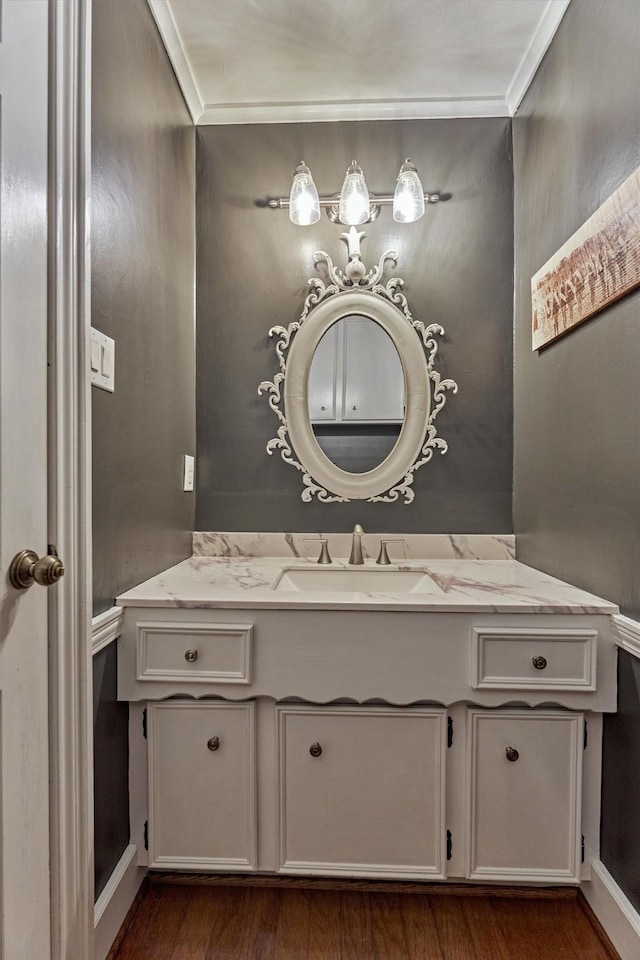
[272,567,442,593]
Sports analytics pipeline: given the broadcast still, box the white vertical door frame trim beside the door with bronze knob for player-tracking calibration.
[49,0,94,960]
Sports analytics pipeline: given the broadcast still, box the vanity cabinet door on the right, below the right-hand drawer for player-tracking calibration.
[466,709,584,883]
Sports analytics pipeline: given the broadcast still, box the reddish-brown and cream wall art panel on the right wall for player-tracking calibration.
[531,168,640,350]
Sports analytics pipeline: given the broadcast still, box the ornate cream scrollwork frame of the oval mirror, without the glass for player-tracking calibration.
[258,227,458,504]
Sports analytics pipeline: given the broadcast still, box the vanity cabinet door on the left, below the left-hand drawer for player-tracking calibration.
[148,700,256,871]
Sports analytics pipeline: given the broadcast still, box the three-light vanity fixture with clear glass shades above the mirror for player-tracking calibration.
[263,157,440,226]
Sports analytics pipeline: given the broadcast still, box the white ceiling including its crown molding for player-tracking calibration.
[149,0,569,123]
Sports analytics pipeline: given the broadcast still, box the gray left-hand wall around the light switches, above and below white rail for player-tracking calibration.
[91,0,195,895]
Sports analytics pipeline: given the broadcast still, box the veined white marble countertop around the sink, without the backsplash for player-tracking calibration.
[116,555,618,614]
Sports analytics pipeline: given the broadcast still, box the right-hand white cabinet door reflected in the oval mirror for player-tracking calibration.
[342,317,404,422]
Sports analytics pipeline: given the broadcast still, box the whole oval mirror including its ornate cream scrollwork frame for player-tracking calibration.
[258,227,458,503]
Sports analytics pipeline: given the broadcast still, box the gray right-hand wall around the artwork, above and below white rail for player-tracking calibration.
[513,0,640,906]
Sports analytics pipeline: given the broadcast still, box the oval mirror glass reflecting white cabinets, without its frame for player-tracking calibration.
[308,314,405,473]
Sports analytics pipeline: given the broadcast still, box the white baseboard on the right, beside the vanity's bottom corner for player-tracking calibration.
[580,860,640,960]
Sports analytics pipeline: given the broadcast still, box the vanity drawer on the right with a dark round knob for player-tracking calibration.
[471,628,598,690]
